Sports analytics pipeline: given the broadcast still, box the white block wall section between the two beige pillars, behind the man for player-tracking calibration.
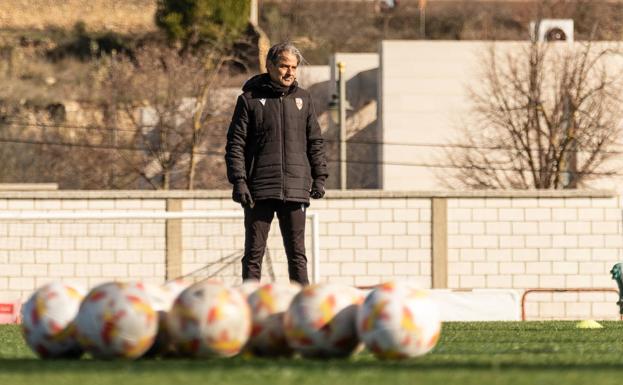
[183,194,431,287]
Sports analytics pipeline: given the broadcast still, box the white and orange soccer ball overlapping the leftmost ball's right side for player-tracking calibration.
[76,282,158,358]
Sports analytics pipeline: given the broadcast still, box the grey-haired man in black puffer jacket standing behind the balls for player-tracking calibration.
[225,43,328,285]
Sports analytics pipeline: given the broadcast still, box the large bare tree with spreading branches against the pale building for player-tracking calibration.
[445,42,623,189]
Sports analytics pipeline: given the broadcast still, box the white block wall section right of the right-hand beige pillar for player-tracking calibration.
[448,196,623,319]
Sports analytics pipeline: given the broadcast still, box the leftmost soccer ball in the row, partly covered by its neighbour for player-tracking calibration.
[22,282,84,358]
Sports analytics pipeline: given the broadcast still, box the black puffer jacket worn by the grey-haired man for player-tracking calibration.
[225,74,328,203]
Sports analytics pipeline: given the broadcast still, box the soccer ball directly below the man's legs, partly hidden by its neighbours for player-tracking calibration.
[246,283,301,356]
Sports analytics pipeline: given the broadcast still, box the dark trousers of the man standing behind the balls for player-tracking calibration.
[242,199,309,285]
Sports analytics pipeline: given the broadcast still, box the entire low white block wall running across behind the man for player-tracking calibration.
[0,191,623,319]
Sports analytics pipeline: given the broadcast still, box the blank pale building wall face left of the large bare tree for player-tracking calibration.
[379,41,486,190]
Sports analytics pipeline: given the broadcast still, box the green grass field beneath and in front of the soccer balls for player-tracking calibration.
[0,322,623,385]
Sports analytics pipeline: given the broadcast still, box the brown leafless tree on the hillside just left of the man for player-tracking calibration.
[104,46,230,189]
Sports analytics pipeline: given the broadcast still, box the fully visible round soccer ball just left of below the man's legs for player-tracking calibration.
[167,281,251,357]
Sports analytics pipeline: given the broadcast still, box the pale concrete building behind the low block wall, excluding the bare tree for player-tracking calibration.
[328,41,623,191]
